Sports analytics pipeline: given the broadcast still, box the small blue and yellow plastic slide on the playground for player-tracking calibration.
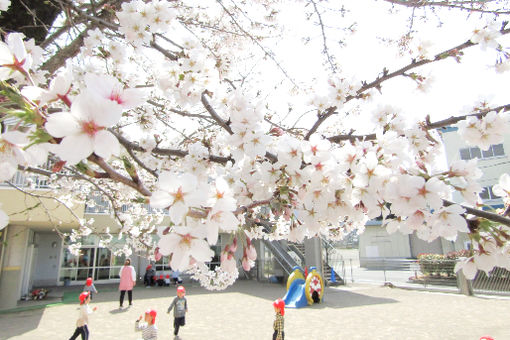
[283,266,324,308]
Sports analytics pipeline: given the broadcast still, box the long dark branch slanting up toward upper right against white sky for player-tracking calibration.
[305,24,510,140]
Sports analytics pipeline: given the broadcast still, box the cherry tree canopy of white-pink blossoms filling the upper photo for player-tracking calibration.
[0,0,510,289]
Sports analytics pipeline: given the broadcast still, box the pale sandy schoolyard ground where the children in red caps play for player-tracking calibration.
[0,281,510,340]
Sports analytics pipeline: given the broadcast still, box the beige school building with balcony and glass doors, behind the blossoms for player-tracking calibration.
[0,172,322,310]
